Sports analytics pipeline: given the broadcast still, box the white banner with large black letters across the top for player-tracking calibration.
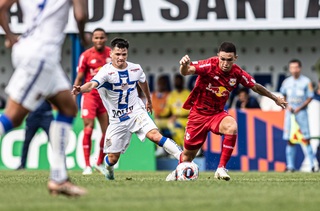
[0,0,320,33]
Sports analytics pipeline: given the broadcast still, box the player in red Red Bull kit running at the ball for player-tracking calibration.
[167,42,287,181]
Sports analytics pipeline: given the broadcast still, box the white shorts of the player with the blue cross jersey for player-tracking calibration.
[103,110,158,154]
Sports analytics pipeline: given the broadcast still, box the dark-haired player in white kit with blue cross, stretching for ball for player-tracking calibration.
[72,38,182,180]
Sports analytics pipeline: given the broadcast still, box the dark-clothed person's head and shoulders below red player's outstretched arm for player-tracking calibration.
[236,87,260,109]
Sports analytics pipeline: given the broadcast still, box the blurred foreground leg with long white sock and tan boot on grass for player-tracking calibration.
[48,90,87,196]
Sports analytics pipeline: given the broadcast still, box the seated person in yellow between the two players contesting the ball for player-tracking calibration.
[167,74,190,147]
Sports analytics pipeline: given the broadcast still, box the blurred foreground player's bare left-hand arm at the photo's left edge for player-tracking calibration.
[0,0,18,48]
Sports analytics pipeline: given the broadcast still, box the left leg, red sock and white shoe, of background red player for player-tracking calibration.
[82,118,94,175]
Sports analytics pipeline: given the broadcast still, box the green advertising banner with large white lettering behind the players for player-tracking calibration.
[0,112,156,171]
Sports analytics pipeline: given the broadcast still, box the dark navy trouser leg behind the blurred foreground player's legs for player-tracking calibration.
[18,119,40,170]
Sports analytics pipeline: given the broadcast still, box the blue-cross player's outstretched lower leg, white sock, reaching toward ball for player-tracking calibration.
[146,129,182,160]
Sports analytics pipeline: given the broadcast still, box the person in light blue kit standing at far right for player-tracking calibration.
[280,59,314,172]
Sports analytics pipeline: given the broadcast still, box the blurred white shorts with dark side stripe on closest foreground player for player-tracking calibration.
[5,57,71,111]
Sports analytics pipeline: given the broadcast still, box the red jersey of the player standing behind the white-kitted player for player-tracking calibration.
[77,47,111,95]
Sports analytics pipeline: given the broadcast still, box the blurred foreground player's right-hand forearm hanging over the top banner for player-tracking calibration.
[72,0,90,46]
